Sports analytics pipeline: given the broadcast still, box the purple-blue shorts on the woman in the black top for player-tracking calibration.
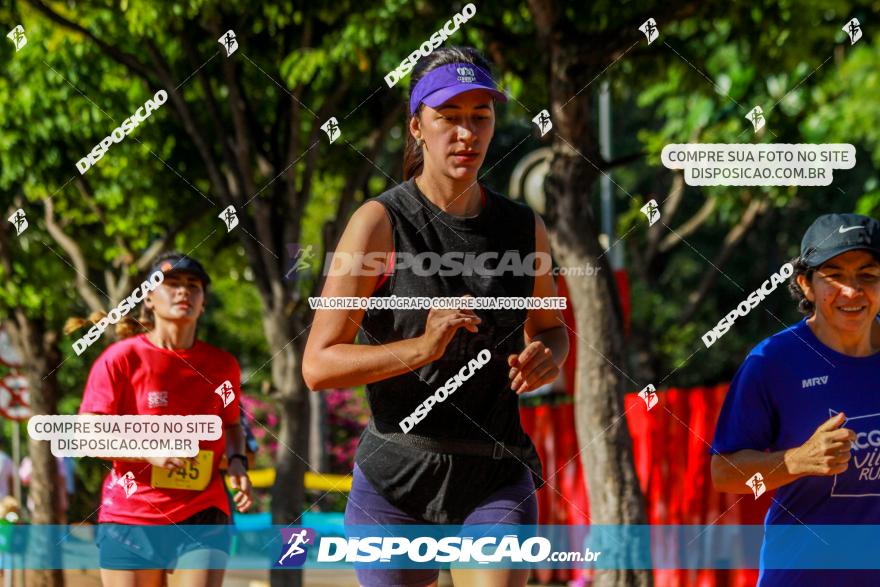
[345,465,538,587]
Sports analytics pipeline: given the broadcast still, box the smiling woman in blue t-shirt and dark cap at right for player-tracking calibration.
[712,214,880,587]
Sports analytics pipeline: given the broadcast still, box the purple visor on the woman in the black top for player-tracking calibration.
[409,63,507,115]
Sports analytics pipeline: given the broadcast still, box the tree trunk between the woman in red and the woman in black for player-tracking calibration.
[264,313,310,587]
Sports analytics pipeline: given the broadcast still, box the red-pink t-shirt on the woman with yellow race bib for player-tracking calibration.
[79,334,241,524]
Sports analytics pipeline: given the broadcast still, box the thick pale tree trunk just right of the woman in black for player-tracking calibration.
[545,42,653,587]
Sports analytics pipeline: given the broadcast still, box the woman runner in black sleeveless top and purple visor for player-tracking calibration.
[303,47,568,587]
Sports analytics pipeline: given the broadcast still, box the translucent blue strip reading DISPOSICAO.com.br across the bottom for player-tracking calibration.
[0,524,880,569]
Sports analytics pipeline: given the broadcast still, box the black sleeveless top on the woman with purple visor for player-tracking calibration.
[355,179,543,524]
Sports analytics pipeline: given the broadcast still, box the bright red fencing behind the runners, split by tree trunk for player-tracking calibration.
[520,384,770,587]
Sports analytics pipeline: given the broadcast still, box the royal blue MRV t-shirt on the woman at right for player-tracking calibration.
[712,318,880,586]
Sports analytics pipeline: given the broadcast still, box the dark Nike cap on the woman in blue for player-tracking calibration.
[801,214,880,268]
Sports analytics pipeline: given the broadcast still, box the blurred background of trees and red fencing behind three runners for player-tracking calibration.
[0,0,880,585]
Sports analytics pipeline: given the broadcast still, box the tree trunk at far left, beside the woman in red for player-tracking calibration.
[9,308,65,587]
